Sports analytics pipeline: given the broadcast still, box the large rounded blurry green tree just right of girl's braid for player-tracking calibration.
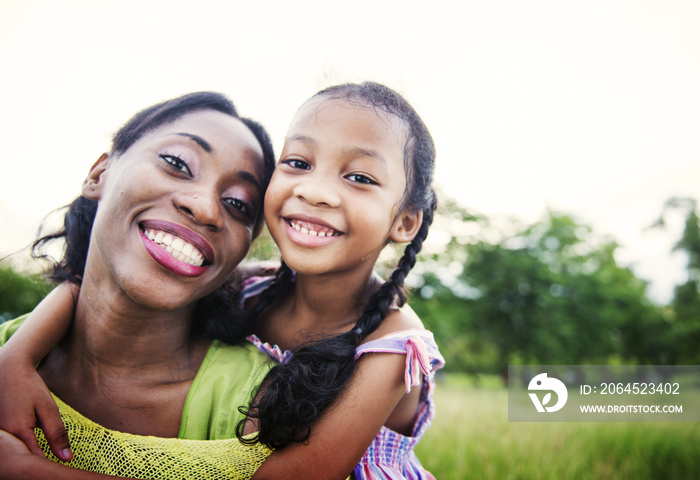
[412,202,668,372]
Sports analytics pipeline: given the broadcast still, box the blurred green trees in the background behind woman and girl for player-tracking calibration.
[0,194,700,375]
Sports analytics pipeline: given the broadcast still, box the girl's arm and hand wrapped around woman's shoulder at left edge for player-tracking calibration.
[0,283,79,461]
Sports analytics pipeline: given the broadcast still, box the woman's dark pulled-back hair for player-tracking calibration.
[32,92,275,341]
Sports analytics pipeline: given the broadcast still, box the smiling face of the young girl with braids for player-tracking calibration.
[265,97,417,274]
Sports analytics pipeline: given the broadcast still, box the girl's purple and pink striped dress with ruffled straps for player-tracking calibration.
[241,277,445,480]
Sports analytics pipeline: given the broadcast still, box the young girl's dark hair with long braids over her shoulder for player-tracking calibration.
[238,82,437,448]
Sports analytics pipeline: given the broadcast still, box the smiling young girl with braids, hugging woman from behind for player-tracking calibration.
[0,83,443,478]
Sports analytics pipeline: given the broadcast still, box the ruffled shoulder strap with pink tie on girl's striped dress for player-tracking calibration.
[355,329,445,393]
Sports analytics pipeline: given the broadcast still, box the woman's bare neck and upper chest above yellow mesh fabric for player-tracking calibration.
[39,276,210,437]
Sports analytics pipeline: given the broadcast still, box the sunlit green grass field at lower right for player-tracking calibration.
[417,376,700,480]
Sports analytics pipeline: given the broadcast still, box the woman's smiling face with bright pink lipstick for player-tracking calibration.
[83,110,264,311]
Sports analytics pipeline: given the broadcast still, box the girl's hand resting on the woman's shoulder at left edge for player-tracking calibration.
[0,355,73,464]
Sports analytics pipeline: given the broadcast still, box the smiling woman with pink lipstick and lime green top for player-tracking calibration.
[3,92,274,476]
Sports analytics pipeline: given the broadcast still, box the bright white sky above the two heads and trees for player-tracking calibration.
[0,0,700,301]
